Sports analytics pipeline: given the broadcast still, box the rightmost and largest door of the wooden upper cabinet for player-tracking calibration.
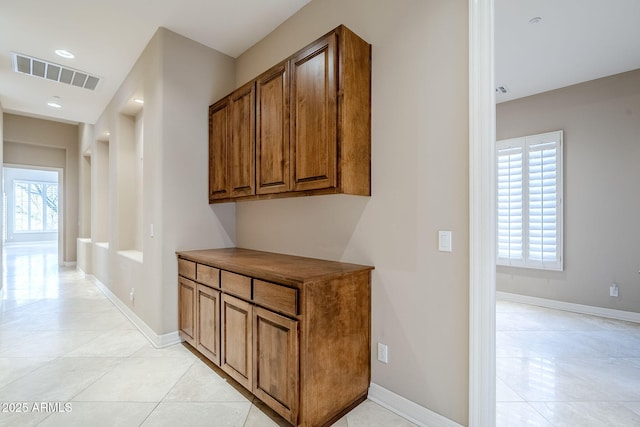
[291,33,338,191]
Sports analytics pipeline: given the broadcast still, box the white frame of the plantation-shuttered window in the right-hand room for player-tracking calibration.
[495,130,564,271]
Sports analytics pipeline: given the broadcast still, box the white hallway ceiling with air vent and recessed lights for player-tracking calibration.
[0,0,310,123]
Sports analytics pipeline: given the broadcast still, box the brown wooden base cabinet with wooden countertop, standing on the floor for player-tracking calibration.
[178,248,373,427]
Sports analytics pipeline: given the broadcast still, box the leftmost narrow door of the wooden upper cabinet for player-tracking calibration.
[209,98,229,203]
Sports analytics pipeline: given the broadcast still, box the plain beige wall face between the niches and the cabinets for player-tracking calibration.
[159,30,236,331]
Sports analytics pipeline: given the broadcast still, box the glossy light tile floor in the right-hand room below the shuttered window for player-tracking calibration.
[496,301,640,427]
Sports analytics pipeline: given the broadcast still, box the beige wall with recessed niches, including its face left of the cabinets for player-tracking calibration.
[79,28,235,339]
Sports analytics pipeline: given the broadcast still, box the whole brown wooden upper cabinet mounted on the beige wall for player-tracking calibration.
[209,26,371,203]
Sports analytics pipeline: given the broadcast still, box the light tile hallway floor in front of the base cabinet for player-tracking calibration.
[0,245,413,427]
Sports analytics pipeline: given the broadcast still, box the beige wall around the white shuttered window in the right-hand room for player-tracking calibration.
[496,70,640,312]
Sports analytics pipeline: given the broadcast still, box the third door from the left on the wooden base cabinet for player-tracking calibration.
[220,294,253,390]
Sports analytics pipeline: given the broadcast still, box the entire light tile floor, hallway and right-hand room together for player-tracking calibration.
[6,242,640,427]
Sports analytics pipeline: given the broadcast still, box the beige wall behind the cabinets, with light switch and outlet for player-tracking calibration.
[236,0,469,424]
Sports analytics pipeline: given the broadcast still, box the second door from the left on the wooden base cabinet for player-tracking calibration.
[196,284,220,366]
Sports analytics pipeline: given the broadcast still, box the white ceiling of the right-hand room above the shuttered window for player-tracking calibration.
[494,0,640,102]
